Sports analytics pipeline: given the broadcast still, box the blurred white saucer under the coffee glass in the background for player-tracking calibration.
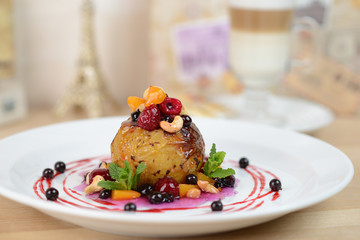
[216,95,334,133]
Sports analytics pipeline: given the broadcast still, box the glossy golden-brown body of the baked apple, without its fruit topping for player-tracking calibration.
[111,119,205,185]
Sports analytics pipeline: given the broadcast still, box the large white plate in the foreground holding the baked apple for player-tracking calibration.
[0,118,353,237]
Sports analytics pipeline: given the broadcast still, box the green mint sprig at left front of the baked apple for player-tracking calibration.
[98,160,146,190]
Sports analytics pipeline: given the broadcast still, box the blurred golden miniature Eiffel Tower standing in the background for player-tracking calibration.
[55,0,109,117]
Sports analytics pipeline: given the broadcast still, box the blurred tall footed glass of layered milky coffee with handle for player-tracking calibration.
[229,0,316,125]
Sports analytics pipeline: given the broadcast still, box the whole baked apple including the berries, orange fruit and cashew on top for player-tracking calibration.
[111,87,205,185]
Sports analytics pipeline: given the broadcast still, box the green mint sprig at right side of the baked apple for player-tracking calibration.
[204,143,235,178]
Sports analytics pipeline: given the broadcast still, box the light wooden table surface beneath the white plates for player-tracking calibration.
[0,109,360,240]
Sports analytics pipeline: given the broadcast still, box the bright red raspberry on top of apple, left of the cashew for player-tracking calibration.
[137,104,161,131]
